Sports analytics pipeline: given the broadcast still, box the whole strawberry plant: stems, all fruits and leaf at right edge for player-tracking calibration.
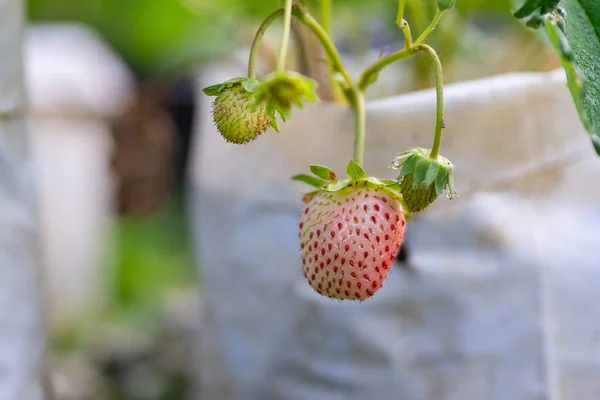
[204,0,600,301]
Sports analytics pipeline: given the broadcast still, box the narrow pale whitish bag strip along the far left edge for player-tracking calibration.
[0,0,44,400]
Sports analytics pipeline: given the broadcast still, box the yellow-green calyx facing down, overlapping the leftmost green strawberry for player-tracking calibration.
[256,71,318,122]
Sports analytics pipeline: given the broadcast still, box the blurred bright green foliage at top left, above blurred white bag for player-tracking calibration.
[28,0,276,76]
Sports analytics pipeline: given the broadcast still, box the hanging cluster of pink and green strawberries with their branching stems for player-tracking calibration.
[204,0,456,301]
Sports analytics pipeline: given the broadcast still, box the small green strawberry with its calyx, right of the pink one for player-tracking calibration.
[391,148,458,213]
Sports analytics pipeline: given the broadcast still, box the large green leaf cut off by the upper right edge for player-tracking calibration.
[563,0,600,155]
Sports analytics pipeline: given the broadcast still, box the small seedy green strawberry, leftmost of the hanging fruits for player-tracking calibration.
[204,78,279,144]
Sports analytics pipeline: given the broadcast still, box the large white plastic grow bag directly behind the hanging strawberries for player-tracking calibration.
[191,60,600,400]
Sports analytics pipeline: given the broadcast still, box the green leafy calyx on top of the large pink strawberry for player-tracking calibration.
[292,160,406,210]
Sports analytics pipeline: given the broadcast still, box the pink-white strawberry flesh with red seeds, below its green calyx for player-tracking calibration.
[300,185,406,301]
